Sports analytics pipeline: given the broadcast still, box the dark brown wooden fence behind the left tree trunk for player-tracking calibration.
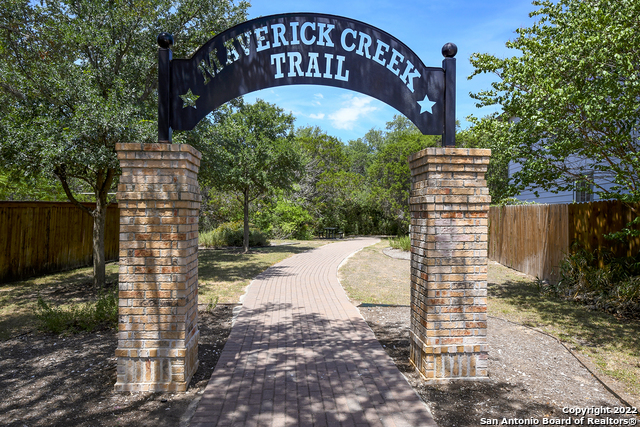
[0,202,120,283]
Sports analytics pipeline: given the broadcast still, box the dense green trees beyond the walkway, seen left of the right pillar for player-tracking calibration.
[291,116,438,234]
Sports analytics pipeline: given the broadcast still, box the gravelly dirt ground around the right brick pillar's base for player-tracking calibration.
[359,305,630,427]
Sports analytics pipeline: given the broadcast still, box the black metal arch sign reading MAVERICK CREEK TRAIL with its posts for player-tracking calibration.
[158,13,457,145]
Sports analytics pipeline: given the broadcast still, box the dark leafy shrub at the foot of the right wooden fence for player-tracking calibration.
[548,247,640,316]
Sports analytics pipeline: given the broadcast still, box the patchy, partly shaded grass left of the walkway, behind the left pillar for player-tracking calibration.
[0,240,327,340]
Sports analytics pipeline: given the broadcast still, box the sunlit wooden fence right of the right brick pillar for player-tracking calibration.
[489,201,640,282]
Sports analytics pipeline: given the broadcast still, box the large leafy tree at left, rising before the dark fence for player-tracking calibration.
[0,0,248,287]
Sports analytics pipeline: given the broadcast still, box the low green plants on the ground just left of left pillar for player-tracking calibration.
[36,287,119,334]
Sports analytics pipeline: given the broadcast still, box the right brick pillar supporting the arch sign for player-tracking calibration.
[409,147,491,381]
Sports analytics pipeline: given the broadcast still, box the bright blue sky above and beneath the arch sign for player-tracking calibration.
[245,0,534,143]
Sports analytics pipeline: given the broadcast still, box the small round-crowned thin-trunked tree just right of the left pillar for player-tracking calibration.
[185,100,301,253]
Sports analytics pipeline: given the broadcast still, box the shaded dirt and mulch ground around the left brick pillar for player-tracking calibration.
[0,305,233,427]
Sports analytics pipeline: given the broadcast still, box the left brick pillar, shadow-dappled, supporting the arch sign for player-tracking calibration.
[115,144,201,392]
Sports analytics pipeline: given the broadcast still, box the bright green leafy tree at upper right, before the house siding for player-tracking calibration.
[470,0,640,207]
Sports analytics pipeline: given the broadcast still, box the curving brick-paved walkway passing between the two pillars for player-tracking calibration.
[191,238,436,427]
